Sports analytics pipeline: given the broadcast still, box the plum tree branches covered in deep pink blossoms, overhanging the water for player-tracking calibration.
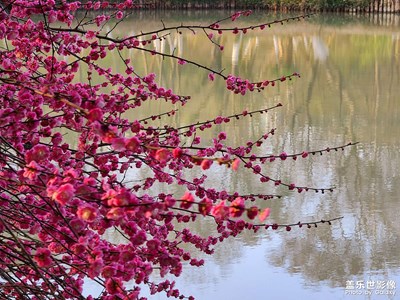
[0,0,352,299]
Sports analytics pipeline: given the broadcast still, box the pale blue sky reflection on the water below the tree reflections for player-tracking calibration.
[125,235,400,300]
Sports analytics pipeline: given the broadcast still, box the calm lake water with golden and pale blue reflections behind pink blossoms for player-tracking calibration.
[81,11,400,300]
